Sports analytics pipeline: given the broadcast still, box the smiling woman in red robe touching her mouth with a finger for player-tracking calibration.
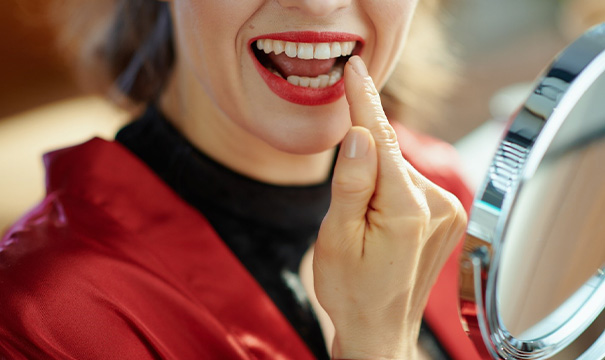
[0,0,482,359]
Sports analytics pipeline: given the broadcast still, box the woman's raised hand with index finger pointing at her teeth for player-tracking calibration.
[313,57,466,359]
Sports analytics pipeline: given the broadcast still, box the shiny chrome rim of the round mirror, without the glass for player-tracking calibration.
[459,23,605,360]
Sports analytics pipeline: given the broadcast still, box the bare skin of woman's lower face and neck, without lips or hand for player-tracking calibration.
[161,0,416,185]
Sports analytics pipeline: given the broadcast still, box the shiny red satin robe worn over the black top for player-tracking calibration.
[0,123,478,360]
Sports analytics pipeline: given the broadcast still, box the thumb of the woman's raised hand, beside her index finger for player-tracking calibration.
[328,126,377,226]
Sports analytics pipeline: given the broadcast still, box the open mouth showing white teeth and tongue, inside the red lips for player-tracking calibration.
[251,39,361,89]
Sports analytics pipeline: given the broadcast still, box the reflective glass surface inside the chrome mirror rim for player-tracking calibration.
[496,63,605,340]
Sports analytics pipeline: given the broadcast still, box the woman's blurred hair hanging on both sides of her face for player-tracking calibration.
[54,0,455,127]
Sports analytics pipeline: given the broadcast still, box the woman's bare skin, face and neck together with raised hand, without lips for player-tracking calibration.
[161,0,466,359]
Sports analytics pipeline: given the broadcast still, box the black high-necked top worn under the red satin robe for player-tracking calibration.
[116,106,447,359]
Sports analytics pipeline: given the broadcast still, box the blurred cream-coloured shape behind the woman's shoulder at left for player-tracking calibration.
[0,97,129,232]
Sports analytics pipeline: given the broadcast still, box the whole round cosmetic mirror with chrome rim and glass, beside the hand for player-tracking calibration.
[460,24,605,360]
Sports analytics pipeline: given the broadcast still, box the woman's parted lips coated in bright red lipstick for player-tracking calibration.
[248,31,363,106]
